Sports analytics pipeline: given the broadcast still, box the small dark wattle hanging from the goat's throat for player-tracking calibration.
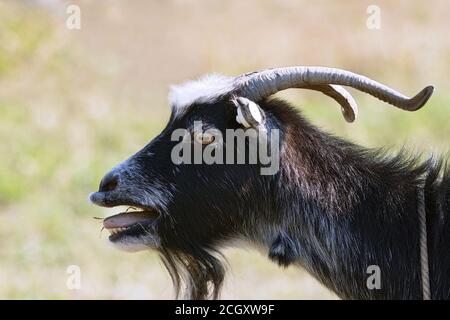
[269,231,299,267]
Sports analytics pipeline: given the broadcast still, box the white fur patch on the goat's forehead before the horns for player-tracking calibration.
[169,74,233,111]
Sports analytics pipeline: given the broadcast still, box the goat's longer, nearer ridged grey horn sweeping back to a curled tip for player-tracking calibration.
[236,67,433,111]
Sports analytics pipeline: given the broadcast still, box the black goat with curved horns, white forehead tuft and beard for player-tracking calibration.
[90,67,450,299]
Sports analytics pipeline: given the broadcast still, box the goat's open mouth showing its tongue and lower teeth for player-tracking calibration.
[103,207,159,242]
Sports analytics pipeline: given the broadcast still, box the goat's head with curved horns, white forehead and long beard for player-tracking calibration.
[90,67,433,298]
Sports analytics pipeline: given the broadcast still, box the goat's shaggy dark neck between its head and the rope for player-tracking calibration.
[250,116,428,299]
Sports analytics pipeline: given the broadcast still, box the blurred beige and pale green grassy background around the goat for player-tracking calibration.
[0,0,450,299]
